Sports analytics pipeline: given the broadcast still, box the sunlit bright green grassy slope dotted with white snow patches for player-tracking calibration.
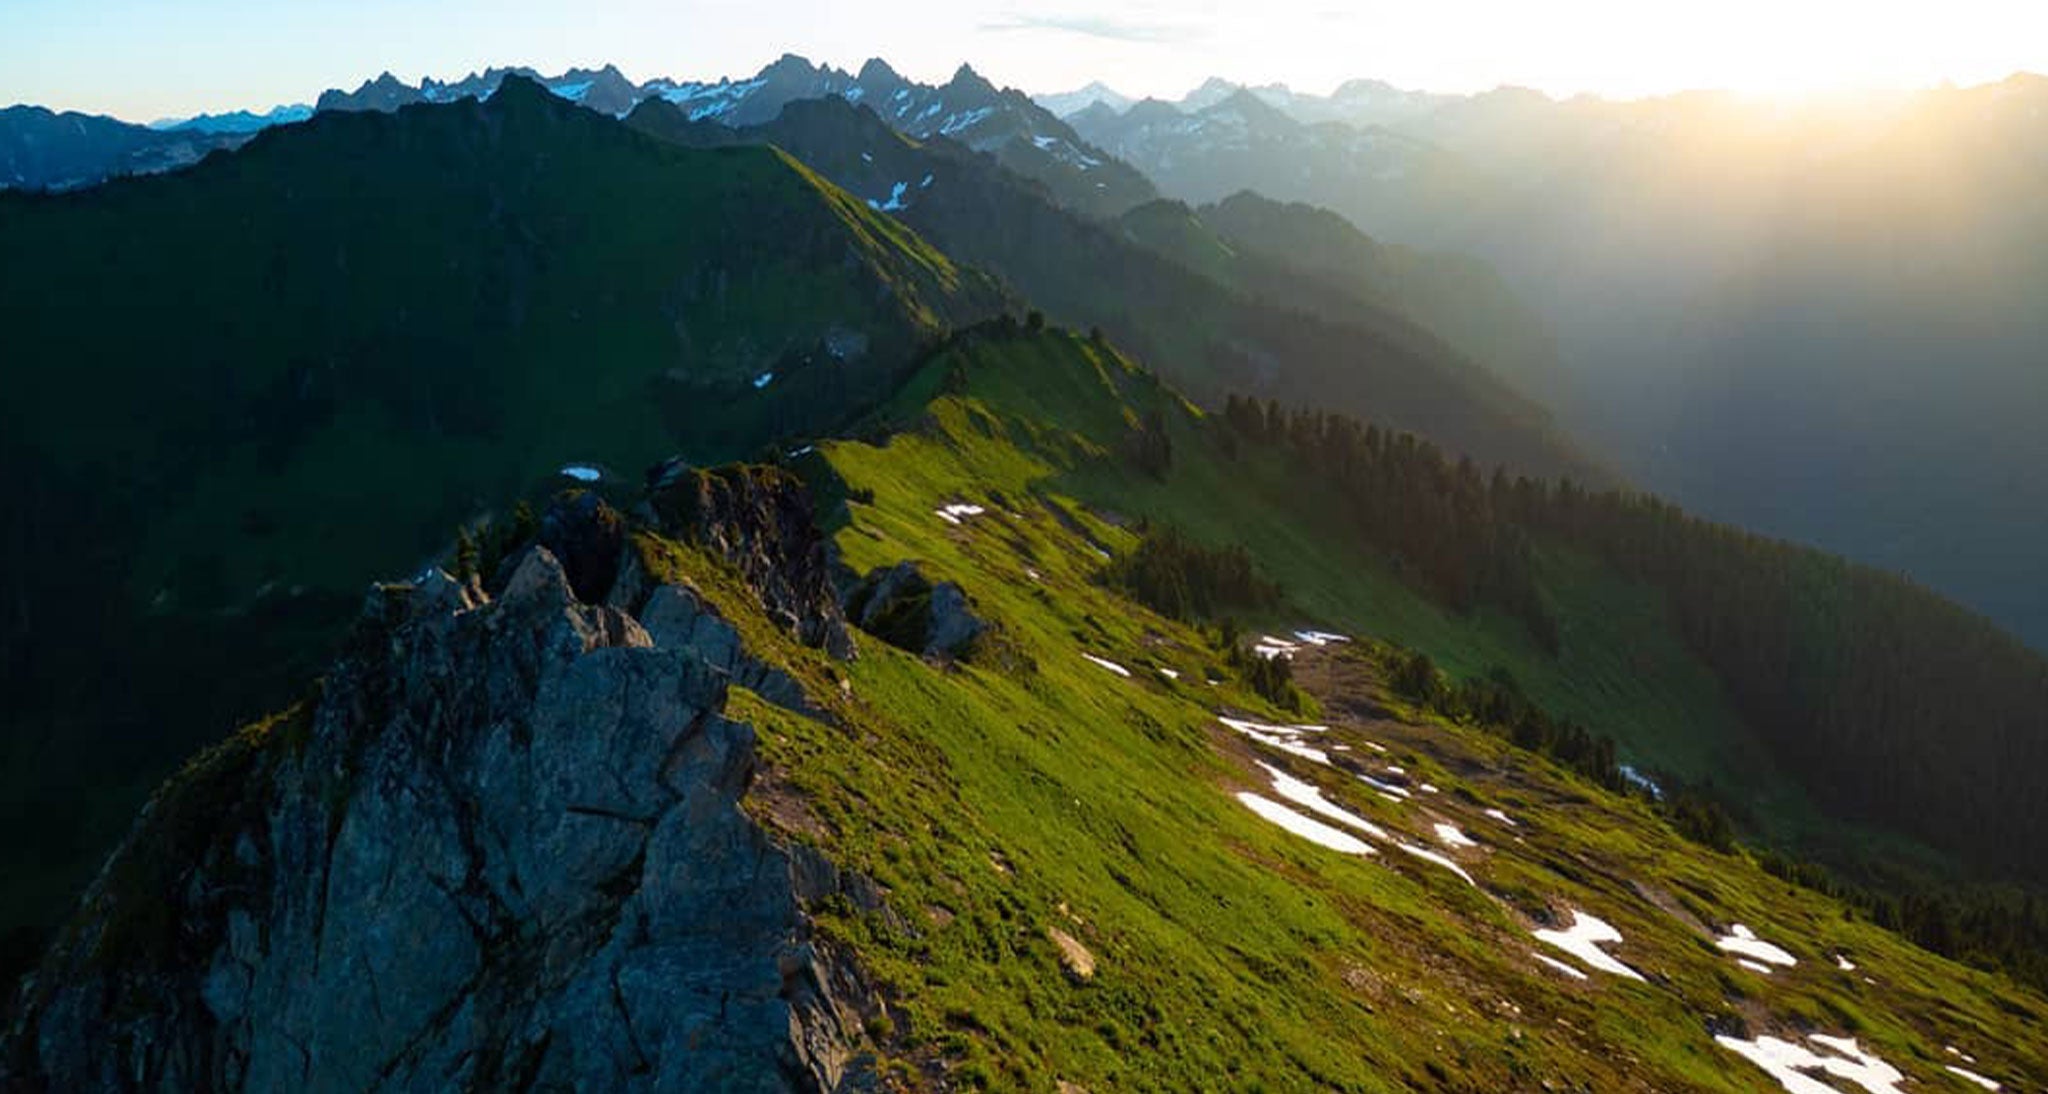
[626,334,2048,1092]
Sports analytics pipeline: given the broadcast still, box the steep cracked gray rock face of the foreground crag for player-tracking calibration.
[0,547,872,1092]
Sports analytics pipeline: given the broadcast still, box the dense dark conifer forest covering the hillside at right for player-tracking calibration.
[1221,397,2048,879]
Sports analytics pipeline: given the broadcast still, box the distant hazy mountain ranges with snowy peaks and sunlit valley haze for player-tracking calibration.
[0,57,2048,643]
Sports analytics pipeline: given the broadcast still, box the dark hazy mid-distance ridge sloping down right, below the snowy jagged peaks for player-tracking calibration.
[631,100,1597,477]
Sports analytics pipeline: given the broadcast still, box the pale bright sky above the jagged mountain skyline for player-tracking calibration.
[0,0,2048,121]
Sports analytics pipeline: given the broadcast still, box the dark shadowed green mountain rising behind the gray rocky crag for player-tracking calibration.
[0,80,1004,966]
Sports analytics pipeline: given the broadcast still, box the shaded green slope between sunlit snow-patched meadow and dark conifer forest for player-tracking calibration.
[847,336,1827,838]
